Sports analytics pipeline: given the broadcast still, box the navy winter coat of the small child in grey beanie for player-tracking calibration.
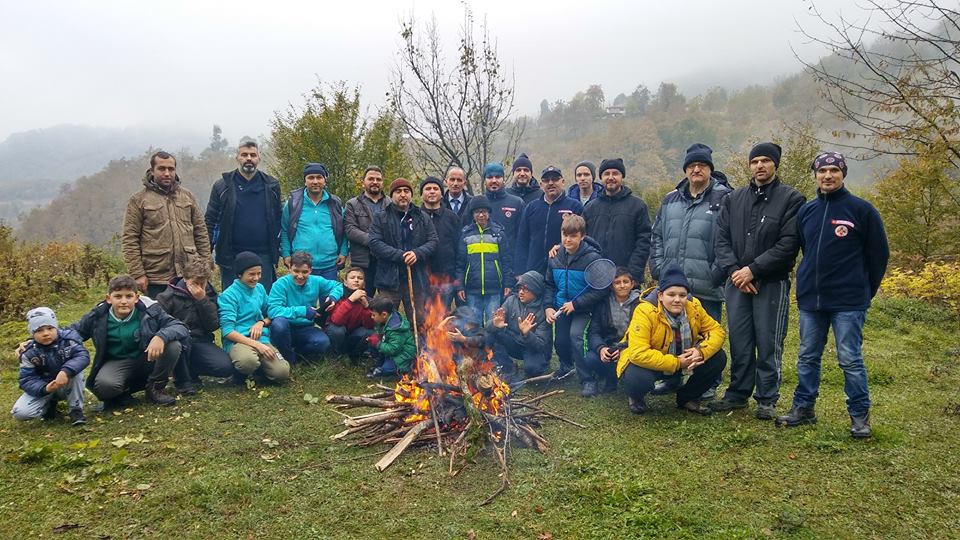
[20,328,90,397]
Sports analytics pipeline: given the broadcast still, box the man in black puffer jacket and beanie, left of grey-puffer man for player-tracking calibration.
[583,158,650,283]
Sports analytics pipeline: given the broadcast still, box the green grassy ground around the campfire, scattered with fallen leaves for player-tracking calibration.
[0,292,960,539]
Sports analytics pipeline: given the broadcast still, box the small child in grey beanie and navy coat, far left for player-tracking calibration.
[10,307,90,426]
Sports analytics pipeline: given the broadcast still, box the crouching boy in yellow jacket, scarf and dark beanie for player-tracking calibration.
[617,263,727,415]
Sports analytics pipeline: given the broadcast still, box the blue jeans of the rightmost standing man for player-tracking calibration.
[793,309,870,416]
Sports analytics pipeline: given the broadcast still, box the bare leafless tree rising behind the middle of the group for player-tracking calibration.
[389,4,526,192]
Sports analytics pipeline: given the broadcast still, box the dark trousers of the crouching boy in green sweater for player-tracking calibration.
[91,341,183,401]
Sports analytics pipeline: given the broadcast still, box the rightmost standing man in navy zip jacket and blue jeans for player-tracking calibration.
[777,152,890,439]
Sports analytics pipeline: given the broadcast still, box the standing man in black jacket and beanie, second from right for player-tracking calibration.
[710,142,803,420]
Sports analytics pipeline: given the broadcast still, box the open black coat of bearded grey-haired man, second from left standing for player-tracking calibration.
[205,170,283,266]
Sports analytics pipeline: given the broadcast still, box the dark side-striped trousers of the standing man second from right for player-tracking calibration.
[724,279,790,405]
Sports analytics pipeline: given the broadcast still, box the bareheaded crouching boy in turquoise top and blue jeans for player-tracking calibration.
[267,251,343,362]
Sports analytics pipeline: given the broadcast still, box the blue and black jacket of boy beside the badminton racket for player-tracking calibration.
[543,236,607,313]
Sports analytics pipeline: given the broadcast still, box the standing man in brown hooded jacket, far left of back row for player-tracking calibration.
[121,150,210,298]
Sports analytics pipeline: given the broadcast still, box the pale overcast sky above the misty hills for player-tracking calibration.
[0,0,872,141]
